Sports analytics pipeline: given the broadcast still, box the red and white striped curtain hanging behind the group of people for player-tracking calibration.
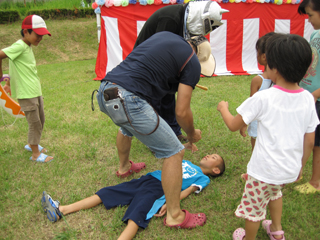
[95,2,313,80]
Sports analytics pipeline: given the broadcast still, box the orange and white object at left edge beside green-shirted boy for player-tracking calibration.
[0,84,25,118]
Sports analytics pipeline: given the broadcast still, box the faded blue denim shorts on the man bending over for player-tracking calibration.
[97,81,184,158]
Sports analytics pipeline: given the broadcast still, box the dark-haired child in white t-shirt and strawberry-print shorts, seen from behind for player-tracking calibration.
[217,34,319,240]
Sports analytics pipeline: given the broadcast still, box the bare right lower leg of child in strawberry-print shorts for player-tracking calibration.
[268,197,282,239]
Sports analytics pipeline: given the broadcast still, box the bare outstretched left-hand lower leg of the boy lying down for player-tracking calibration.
[59,194,102,215]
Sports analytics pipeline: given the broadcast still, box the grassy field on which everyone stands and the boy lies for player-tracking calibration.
[0,19,320,240]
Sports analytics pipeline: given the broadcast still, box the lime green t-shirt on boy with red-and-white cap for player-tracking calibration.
[2,39,42,99]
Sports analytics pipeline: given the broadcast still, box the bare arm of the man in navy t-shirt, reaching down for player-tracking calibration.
[176,83,201,143]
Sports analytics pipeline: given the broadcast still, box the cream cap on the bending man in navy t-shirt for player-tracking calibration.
[190,35,216,77]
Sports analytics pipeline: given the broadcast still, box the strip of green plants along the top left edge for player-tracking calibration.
[0,0,88,16]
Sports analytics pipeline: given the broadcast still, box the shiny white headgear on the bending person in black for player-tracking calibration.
[187,1,229,36]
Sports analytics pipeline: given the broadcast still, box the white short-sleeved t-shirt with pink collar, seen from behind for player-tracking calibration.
[237,85,319,185]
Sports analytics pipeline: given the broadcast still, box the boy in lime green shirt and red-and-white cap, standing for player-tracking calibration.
[0,15,53,162]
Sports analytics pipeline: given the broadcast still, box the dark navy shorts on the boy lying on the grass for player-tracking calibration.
[96,175,164,228]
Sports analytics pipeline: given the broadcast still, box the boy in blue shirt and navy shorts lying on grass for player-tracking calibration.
[41,154,225,239]
